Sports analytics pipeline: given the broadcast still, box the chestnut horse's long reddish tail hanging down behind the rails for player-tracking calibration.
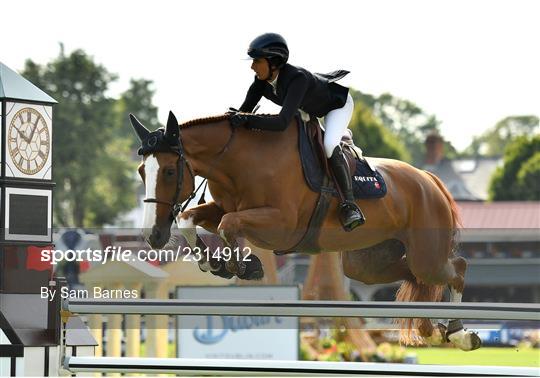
[396,171,462,345]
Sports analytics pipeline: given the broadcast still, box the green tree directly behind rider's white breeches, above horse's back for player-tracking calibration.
[350,94,410,161]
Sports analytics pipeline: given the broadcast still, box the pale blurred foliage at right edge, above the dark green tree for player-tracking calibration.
[464,115,540,157]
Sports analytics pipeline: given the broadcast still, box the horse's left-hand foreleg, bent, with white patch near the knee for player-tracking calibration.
[176,201,233,278]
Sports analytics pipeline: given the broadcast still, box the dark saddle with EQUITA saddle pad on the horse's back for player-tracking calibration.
[298,117,386,199]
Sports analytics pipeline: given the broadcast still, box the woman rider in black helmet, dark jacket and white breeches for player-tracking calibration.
[231,33,365,231]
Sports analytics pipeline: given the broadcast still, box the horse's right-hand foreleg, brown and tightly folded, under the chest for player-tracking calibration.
[218,207,281,280]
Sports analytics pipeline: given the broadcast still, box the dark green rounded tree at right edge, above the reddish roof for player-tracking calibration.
[489,134,540,201]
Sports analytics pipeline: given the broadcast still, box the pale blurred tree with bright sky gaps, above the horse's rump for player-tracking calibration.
[351,90,448,166]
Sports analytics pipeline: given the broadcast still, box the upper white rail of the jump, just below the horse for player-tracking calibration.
[63,299,540,320]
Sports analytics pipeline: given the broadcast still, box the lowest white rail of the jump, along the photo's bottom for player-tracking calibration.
[64,357,540,377]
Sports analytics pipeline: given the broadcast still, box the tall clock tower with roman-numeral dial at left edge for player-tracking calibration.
[0,62,60,376]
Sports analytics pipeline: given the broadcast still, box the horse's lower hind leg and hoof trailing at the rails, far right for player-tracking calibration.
[446,257,482,351]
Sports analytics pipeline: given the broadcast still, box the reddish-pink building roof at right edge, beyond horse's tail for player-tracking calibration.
[458,201,540,229]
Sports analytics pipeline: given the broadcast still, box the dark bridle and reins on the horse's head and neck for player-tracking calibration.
[143,121,235,222]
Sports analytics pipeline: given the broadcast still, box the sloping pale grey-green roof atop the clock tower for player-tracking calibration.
[0,62,56,104]
